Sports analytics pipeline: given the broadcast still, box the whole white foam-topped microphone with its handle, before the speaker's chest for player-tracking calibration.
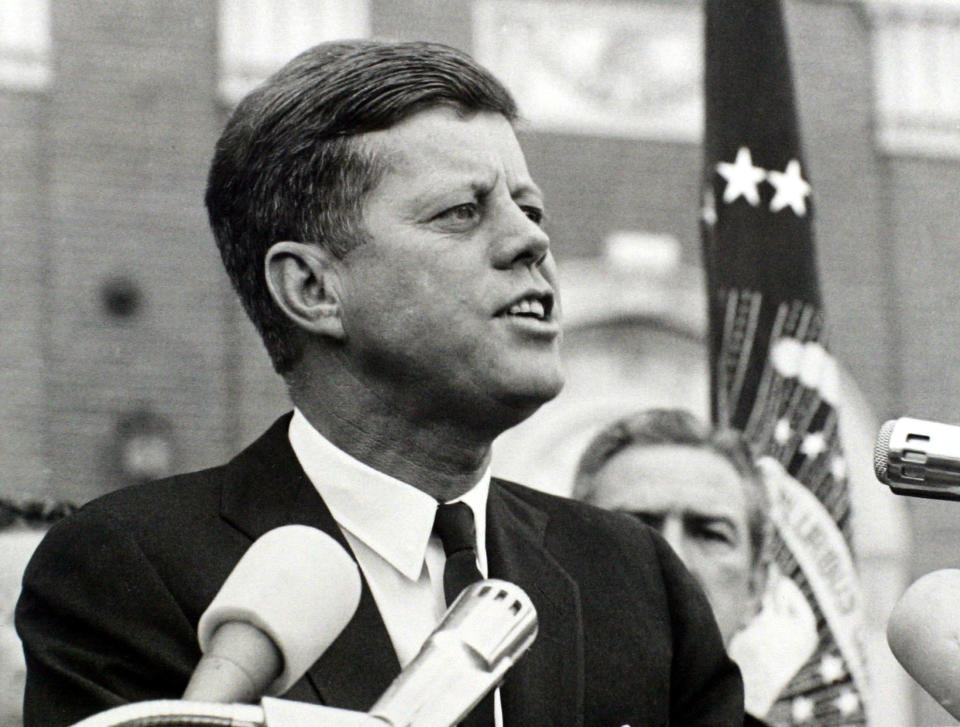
[183,525,360,703]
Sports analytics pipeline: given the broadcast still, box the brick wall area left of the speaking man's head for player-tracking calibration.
[0,0,233,500]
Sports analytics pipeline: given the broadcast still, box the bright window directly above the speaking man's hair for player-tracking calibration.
[219,0,370,105]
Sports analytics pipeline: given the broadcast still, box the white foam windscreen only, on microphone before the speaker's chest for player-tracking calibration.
[197,525,360,696]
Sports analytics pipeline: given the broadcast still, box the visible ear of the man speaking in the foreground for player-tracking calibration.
[266,241,344,340]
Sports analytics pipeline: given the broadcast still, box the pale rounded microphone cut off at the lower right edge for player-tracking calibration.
[887,569,960,719]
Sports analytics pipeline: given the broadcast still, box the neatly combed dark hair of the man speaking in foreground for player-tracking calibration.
[206,40,517,374]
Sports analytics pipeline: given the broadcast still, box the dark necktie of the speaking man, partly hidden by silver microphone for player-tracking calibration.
[433,502,494,727]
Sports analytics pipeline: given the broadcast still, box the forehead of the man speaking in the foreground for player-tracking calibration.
[364,107,538,191]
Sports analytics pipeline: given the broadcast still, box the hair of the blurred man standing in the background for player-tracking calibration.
[573,409,769,566]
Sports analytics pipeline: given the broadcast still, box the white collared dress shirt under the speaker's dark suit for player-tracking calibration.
[289,409,503,727]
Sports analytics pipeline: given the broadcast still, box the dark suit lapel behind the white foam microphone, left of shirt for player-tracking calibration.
[221,415,400,710]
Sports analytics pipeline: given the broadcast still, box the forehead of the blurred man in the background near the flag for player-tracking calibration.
[595,444,747,522]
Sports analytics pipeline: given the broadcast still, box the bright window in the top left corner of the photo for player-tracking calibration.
[0,0,51,90]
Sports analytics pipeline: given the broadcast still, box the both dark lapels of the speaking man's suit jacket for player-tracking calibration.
[221,415,583,727]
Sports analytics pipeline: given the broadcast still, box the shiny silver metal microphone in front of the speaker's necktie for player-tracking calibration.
[369,578,537,727]
